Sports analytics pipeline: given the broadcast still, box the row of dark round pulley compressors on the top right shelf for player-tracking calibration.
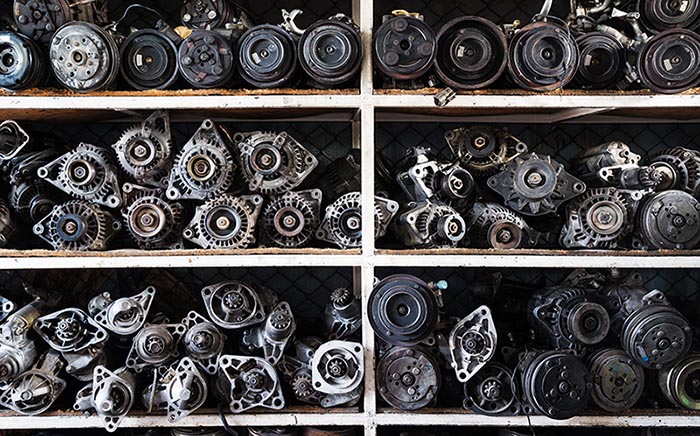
[374,0,700,93]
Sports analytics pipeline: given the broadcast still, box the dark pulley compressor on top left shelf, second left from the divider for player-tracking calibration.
[238,24,298,88]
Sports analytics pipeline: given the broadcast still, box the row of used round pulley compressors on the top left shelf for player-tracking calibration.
[0,0,363,92]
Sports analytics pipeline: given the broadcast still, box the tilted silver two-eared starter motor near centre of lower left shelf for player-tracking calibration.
[126,324,187,372]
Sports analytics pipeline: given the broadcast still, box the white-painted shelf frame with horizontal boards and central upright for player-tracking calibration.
[0,0,700,436]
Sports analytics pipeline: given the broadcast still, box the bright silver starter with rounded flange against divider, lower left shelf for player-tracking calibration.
[311,341,365,405]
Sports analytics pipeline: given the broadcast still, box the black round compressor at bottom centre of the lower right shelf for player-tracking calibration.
[516,351,593,420]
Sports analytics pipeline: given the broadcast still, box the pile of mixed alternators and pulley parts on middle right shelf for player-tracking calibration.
[384,126,700,250]
